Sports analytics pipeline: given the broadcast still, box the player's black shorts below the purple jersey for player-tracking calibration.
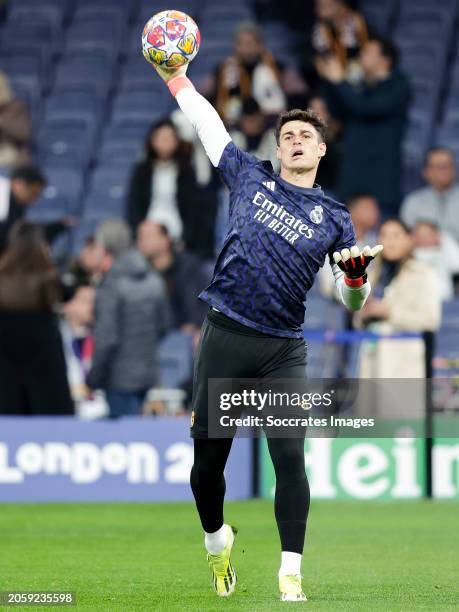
[190,309,306,438]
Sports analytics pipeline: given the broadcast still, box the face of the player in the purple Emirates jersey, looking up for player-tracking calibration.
[277,120,327,172]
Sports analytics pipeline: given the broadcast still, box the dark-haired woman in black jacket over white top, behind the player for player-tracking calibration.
[127,119,216,254]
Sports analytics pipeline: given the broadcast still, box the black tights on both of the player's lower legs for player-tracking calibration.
[190,438,309,554]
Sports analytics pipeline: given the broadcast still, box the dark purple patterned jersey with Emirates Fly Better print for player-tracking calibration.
[199,142,356,338]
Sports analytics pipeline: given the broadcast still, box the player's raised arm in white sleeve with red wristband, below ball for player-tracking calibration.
[155,66,231,167]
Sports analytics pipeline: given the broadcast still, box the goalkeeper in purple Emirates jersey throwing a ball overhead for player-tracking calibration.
[156,67,382,601]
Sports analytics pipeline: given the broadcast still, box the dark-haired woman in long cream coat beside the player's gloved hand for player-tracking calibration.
[355,219,440,382]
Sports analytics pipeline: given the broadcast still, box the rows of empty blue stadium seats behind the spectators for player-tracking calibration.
[0,0,459,412]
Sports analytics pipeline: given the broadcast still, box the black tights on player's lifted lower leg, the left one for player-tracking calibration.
[190,438,233,533]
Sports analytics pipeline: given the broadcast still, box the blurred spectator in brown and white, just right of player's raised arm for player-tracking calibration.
[203,23,286,126]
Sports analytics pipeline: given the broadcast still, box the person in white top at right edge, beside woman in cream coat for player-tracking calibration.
[413,221,459,300]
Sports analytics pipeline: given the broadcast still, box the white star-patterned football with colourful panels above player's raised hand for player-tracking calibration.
[142,10,201,68]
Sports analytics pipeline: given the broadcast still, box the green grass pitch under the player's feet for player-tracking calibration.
[0,500,459,612]
